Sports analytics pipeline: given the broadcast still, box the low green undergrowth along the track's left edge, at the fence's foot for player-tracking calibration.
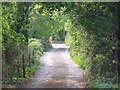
[2,56,40,87]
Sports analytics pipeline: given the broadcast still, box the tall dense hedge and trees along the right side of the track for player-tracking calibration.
[64,2,118,88]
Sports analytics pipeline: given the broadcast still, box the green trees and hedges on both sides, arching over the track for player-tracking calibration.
[0,2,119,88]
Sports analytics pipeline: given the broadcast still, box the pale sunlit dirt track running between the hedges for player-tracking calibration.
[23,44,87,88]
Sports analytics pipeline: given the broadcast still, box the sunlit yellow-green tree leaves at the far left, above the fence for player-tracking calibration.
[2,3,25,50]
